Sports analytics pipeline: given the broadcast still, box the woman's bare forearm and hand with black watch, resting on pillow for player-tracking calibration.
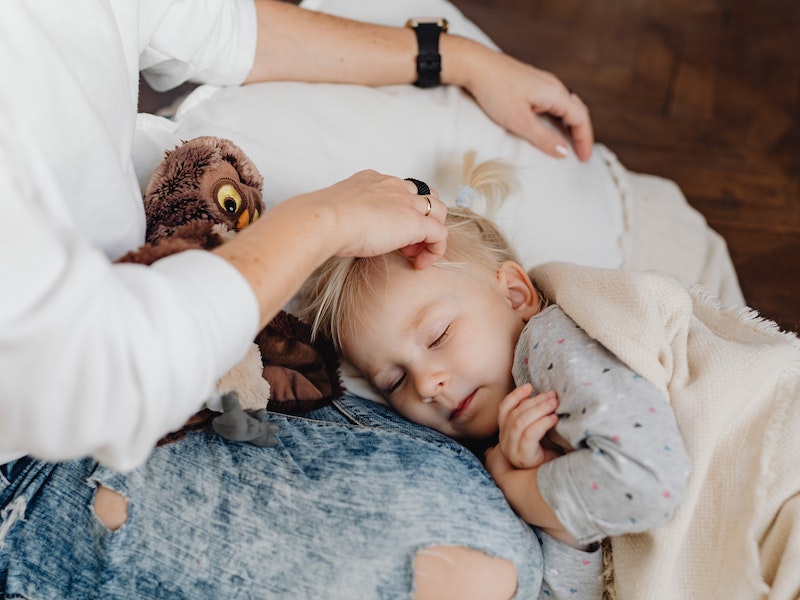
[246,0,594,160]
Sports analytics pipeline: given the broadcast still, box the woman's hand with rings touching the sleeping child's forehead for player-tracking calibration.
[307,171,447,269]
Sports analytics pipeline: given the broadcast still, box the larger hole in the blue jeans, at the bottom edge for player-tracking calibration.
[414,546,517,600]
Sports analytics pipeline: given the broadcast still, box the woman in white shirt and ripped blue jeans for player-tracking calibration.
[0,0,593,598]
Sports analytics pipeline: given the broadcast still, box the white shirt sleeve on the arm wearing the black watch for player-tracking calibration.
[139,0,257,91]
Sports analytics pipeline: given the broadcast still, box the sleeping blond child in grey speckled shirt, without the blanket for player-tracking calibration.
[300,164,689,546]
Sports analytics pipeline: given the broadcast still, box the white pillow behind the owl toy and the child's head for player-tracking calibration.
[136,0,624,268]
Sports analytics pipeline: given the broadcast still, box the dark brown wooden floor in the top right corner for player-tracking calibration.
[452,0,800,331]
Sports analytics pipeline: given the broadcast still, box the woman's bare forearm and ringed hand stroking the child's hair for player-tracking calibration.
[214,171,447,327]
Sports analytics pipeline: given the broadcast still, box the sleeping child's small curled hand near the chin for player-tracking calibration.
[498,383,558,469]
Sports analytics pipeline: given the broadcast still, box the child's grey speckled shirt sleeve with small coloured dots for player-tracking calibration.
[514,306,691,544]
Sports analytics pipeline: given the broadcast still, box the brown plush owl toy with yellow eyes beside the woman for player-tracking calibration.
[119,136,342,445]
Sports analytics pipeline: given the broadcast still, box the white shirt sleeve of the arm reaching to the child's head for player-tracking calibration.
[0,129,258,470]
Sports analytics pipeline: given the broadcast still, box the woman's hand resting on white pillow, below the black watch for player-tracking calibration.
[441,35,594,161]
